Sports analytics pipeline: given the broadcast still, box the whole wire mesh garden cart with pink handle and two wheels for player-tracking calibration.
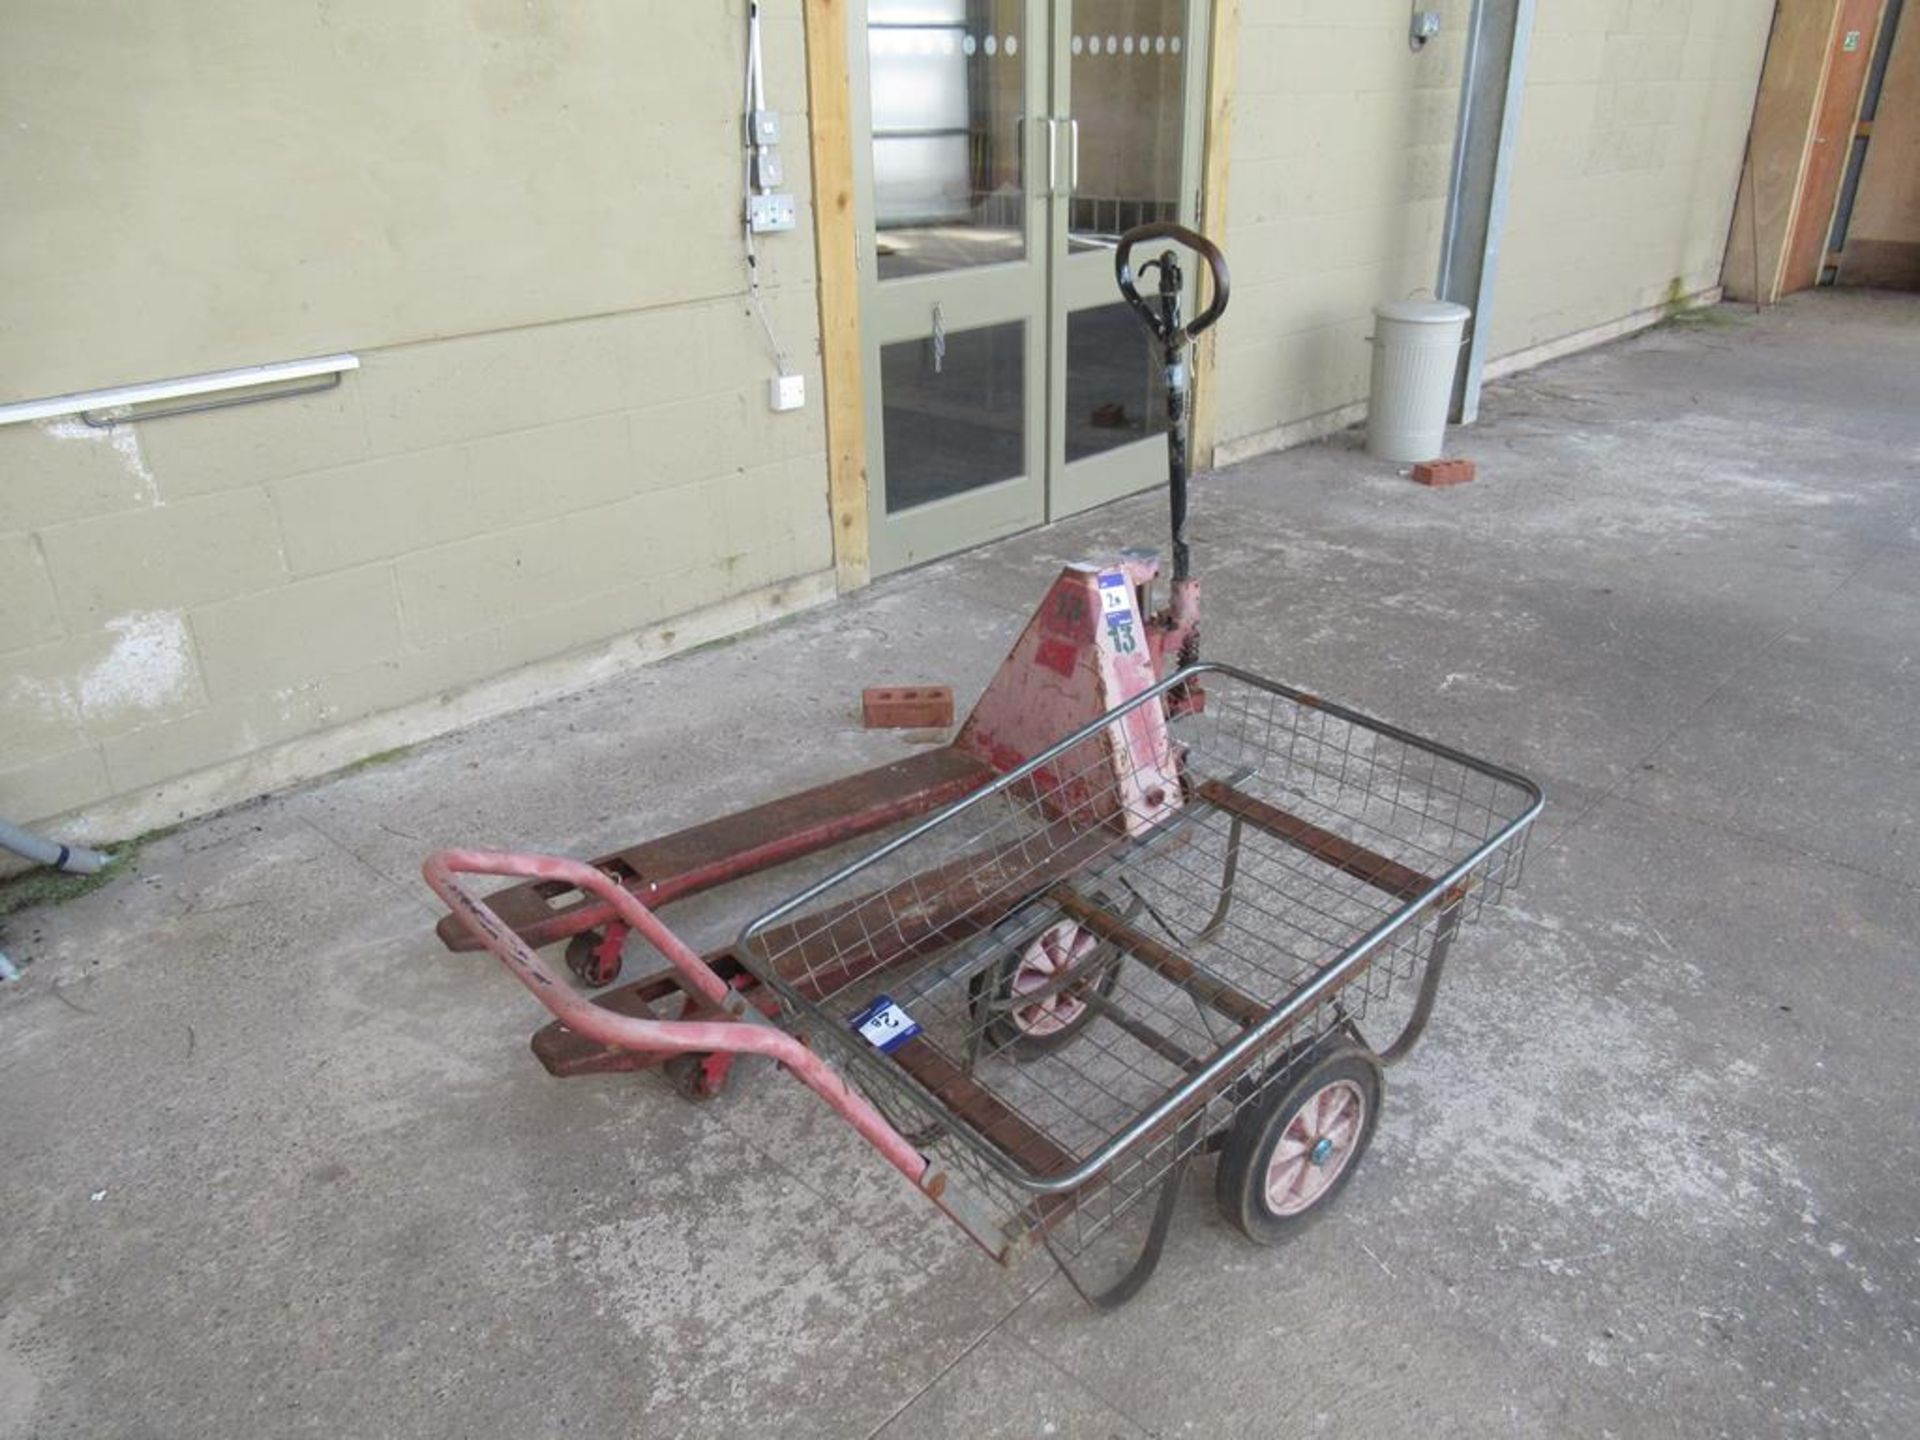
[428,664,1542,1304]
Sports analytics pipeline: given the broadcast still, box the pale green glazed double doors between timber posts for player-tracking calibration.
[849,0,1206,574]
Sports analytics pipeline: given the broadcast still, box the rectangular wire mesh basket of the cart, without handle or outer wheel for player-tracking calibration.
[741,666,1538,1254]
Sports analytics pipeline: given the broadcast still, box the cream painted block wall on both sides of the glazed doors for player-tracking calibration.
[0,0,1768,839]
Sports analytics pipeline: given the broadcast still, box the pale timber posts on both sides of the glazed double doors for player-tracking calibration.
[803,0,1240,593]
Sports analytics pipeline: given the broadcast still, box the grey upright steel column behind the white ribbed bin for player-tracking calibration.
[1434,0,1534,424]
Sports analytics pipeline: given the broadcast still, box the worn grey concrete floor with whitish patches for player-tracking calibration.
[0,294,1920,1440]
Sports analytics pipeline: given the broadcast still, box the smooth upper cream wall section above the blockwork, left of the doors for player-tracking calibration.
[0,0,812,399]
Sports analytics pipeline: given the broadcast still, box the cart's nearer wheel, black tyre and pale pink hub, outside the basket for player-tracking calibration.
[1213,1039,1384,1244]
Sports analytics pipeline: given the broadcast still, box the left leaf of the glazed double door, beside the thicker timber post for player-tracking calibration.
[849,0,1058,572]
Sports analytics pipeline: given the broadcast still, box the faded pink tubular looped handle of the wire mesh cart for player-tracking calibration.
[420,851,939,1198]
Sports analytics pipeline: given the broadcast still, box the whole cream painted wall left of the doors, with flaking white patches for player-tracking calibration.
[0,0,831,839]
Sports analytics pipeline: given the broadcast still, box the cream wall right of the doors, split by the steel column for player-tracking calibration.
[1217,0,1772,455]
